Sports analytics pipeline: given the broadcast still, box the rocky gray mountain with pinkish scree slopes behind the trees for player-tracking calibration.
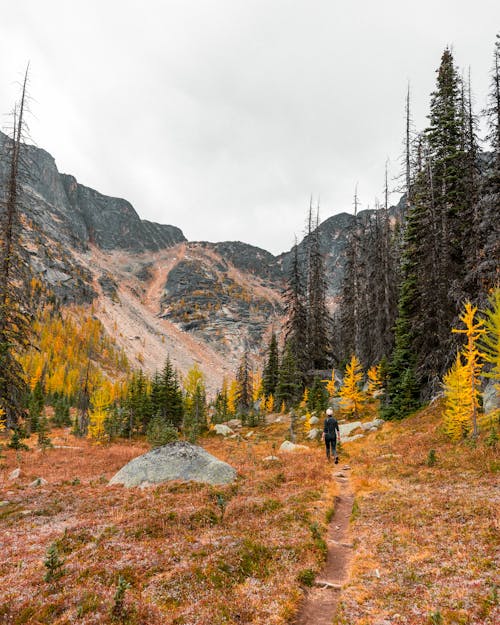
[0,133,398,385]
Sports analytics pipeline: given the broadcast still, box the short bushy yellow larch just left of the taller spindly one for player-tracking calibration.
[443,354,473,440]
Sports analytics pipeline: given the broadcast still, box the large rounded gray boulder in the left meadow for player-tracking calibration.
[109,441,236,487]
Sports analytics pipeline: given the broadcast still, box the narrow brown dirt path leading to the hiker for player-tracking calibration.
[294,467,354,625]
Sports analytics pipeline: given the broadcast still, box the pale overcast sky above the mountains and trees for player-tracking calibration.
[0,0,500,253]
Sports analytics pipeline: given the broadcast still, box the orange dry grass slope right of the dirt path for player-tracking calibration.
[335,404,500,625]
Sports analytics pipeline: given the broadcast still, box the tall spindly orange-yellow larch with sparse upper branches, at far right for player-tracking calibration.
[452,302,486,436]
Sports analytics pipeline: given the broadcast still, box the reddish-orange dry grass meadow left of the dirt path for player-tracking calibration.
[0,425,335,625]
